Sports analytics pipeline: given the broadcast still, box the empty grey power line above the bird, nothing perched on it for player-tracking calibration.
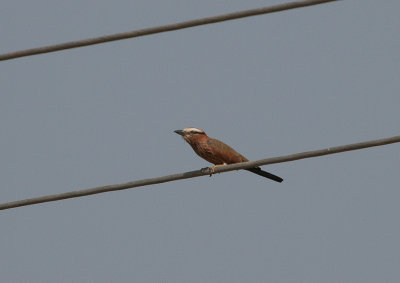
[0,0,338,61]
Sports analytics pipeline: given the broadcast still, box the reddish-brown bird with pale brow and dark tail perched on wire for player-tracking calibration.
[174,127,283,183]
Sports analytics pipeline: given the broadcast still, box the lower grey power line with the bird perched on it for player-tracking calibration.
[0,136,400,210]
